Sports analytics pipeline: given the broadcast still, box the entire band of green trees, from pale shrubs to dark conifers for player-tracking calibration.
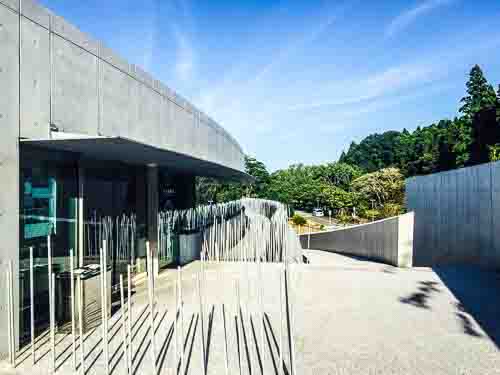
[197,66,500,222]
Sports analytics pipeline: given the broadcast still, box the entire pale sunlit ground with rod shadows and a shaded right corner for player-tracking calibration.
[0,250,500,375]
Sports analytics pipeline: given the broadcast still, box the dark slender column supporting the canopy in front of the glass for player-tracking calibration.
[147,164,159,275]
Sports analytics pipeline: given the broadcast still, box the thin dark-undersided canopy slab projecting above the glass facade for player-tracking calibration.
[21,134,254,183]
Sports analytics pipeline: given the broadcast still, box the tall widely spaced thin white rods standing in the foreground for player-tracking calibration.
[2,253,297,375]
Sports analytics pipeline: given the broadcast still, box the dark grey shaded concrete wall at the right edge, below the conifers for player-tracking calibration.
[406,162,500,268]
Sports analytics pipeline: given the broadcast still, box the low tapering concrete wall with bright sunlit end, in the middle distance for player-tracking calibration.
[300,212,413,267]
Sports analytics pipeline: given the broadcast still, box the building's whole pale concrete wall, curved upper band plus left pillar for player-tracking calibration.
[0,0,244,359]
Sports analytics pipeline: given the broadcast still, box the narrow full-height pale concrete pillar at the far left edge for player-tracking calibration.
[0,4,20,360]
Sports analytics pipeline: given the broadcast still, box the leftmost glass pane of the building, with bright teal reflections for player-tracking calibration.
[19,146,78,341]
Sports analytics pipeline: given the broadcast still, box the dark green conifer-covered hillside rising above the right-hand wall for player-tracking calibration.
[339,65,500,176]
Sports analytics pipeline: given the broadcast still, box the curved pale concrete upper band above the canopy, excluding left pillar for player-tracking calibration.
[0,0,244,177]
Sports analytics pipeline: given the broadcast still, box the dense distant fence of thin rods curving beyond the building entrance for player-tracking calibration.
[158,198,302,262]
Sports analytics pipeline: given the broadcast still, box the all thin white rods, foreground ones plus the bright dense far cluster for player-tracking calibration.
[6,199,297,375]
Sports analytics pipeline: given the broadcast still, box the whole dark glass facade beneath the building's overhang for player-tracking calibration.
[19,145,194,344]
